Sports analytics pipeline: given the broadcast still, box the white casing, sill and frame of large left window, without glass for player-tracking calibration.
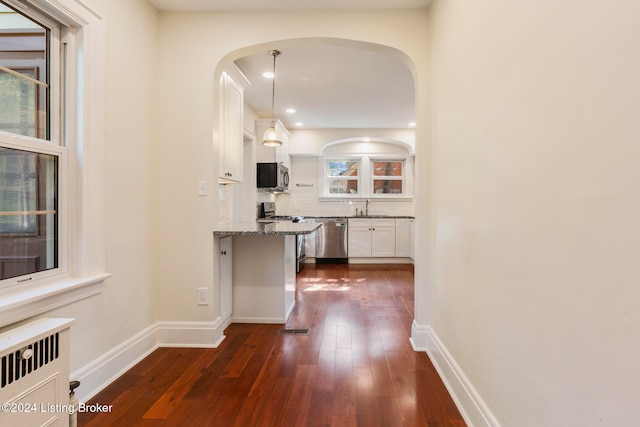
[0,0,109,327]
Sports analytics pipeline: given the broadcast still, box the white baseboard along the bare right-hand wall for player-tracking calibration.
[411,320,500,427]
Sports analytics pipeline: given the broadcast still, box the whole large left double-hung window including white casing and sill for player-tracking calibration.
[0,0,109,326]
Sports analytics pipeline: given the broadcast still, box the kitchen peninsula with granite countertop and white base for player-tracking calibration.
[213,221,321,323]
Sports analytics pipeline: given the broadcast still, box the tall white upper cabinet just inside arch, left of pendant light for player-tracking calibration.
[219,65,249,183]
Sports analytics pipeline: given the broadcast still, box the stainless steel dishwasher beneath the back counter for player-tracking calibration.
[316,218,349,264]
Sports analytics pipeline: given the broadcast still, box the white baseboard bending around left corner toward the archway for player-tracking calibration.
[70,319,228,402]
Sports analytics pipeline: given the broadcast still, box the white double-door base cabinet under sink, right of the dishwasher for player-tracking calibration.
[349,218,396,258]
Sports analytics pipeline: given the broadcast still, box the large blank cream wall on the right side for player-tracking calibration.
[424,0,640,427]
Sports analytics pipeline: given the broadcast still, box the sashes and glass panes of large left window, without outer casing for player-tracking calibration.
[0,3,66,280]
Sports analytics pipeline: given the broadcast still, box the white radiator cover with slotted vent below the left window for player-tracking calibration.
[0,319,74,427]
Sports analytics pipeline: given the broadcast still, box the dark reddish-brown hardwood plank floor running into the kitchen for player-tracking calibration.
[78,264,465,427]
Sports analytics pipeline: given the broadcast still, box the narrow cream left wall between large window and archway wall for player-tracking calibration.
[42,0,157,398]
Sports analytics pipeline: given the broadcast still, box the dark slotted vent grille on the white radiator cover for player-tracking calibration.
[0,333,60,389]
